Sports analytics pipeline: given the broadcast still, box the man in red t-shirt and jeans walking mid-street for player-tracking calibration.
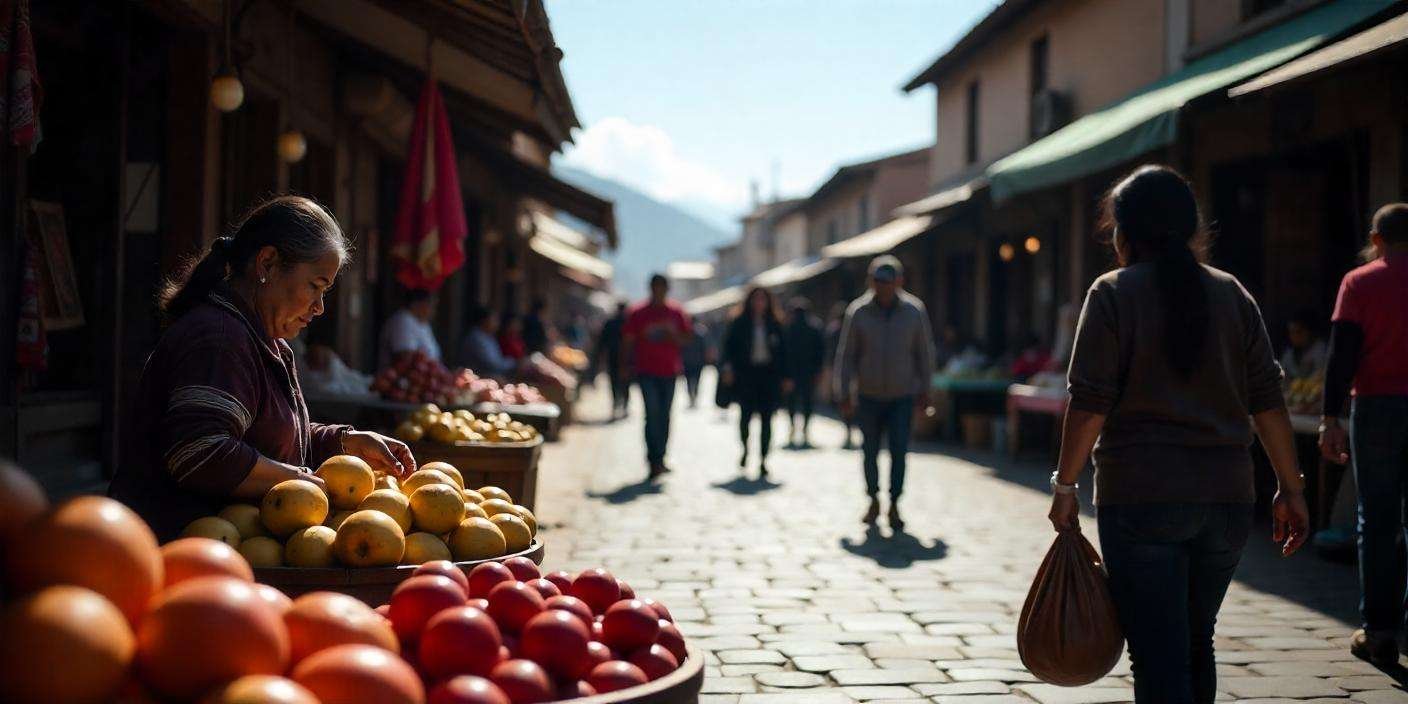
[621,275,693,480]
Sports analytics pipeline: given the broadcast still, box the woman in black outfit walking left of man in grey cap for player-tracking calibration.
[722,287,791,479]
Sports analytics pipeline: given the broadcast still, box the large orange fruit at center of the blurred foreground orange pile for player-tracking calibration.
[137,577,289,700]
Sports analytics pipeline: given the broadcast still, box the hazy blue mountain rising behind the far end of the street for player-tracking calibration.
[552,166,738,297]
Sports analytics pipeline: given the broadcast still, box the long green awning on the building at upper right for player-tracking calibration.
[987,0,1397,201]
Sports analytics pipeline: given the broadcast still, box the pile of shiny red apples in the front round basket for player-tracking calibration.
[377,558,686,704]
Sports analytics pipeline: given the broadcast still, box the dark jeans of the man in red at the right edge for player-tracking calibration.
[1349,396,1408,635]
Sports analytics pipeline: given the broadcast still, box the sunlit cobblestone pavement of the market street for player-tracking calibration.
[538,380,1408,704]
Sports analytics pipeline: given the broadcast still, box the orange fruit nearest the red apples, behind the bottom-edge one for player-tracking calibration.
[283,591,401,665]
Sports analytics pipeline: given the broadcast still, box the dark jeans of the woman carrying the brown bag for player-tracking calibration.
[1097,504,1252,704]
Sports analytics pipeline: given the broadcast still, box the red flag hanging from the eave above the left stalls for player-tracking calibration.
[391,76,469,290]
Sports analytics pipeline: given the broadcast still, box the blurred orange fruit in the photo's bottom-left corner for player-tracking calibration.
[0,584,137,704]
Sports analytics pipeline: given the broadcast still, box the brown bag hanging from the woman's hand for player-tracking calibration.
[1017,529,1125,687]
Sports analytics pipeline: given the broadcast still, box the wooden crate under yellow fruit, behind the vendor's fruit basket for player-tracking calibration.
[410,435,542,511]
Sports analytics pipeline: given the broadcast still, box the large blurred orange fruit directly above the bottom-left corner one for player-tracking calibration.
[6,496,163,624]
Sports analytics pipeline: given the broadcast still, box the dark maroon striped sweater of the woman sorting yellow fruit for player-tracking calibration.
[108,289,348,541]
